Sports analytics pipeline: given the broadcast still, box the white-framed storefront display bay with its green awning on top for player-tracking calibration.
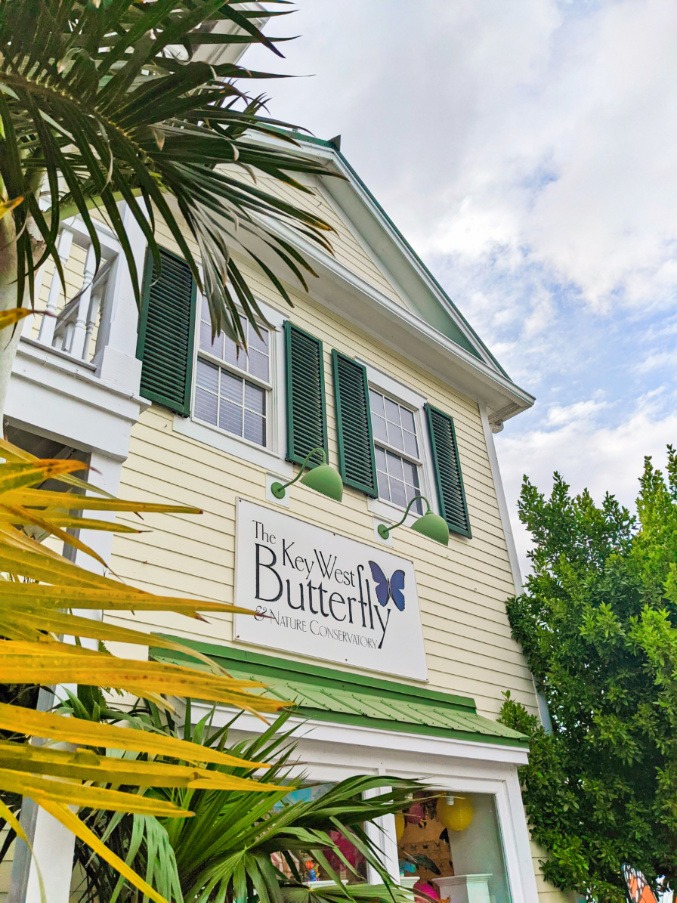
[157,644,537,903]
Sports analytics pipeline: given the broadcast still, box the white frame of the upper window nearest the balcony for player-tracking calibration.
[174,292,292,478]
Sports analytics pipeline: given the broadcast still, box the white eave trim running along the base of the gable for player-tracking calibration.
[243,218,534,422]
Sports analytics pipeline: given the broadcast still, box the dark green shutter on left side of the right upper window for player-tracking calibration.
[331,350,378,498]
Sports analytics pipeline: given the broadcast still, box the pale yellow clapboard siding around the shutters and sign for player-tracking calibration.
[112,214,536,728]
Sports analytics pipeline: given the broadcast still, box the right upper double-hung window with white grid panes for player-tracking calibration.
[369,388,423,514]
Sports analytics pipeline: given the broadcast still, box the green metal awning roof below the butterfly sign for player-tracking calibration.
[153,636,527,747]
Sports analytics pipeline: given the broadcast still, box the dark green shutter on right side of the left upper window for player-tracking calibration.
[284,320,327,466]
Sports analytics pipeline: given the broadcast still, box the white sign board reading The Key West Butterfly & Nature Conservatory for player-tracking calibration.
[234,499,428,680]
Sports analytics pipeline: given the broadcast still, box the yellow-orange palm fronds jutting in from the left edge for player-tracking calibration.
[0,441,290,903]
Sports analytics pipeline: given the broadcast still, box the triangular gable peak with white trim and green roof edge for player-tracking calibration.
[248,133,533,426]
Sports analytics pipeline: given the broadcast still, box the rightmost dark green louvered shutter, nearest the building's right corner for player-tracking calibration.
[425,404,471,537]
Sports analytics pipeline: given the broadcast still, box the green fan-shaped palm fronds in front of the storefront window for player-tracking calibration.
[71,703,414,903]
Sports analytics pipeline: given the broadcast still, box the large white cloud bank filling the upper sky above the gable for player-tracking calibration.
[248,0,677,312]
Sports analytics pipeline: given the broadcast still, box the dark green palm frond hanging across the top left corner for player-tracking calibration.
[0,0,331,342]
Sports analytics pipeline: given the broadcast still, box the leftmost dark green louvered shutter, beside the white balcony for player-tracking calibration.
[136,251,196,417]
